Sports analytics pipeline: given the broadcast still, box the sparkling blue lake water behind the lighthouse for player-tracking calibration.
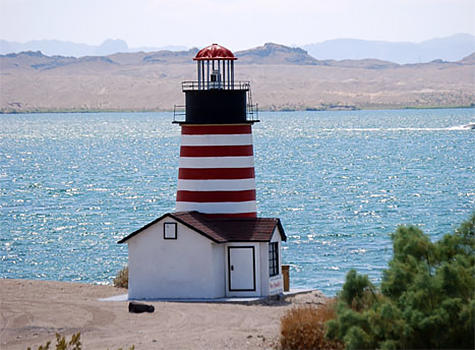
[0,109,475,295]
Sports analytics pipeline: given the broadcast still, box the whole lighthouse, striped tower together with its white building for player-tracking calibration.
[118,44,286,300]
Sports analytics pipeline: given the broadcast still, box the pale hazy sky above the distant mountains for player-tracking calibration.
[0,0,475,50]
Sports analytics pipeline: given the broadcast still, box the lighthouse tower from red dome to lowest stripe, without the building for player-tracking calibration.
[175,44,257,217]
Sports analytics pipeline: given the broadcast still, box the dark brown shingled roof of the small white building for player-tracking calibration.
[118,211,287,243]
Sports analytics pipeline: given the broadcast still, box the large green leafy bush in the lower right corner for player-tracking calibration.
[326,213,475,349]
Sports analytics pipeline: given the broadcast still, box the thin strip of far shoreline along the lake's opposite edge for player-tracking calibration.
[0,103,475,115]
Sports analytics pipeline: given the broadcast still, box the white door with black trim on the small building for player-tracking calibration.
[228,247,256,292]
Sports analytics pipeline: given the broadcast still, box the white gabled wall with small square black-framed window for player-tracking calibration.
[127,217,225,299]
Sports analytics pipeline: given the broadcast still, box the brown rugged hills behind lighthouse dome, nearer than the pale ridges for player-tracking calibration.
[6,43,468,73]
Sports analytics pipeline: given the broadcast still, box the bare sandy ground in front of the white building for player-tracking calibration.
[0,279,326,350]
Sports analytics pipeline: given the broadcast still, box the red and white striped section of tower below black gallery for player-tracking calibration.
[176,124,257,217]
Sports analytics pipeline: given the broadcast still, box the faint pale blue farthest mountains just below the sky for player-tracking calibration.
[0,34,475,64]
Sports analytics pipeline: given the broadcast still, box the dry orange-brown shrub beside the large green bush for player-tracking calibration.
[280,302,343,350]
